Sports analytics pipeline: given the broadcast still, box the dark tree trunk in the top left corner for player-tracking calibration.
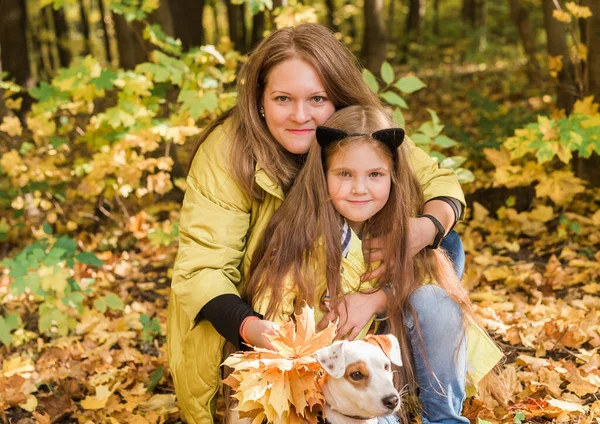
[0,0,31,86]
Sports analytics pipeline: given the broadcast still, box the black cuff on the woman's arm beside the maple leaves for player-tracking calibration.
[195,294,262,350]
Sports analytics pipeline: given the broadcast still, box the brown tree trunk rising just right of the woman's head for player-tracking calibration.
[362,0,386,75]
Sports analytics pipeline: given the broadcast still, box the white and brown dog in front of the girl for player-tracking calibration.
[315,334,402,424]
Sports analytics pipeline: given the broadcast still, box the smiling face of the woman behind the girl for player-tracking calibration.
[263,59,335,154]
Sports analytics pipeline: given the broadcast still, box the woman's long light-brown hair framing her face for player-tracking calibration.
[190,24,380,201]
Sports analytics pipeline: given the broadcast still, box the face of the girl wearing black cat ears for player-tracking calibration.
[327,142,392,233]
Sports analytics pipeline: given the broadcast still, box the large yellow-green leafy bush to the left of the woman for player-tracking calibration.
[0,19,241,241]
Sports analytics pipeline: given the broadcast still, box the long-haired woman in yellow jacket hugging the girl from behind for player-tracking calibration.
[167,24,465,424]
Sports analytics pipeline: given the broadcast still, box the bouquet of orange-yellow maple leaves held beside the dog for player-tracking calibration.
[223,306,336,424]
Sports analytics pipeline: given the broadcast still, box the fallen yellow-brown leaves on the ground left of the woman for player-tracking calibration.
[0,235,181,424]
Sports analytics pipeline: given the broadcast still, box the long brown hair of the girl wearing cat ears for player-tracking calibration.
[243,106,473,418]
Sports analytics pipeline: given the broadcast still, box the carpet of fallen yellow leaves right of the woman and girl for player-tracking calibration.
[462,183,600,423]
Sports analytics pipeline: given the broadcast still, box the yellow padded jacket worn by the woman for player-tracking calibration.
[167,122,465,424]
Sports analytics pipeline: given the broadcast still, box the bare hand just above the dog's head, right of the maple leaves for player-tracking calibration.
[317,290,387,340]
